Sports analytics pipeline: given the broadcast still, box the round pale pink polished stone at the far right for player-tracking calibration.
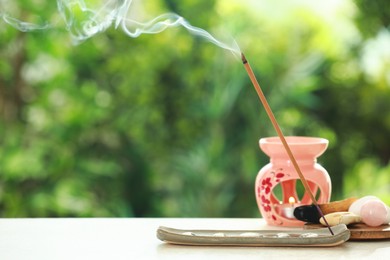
[360,200,387,227]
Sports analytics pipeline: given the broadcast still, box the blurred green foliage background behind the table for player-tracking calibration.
[0,0,390,217]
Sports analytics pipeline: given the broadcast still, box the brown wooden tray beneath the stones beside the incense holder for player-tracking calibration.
[304,223,390,240]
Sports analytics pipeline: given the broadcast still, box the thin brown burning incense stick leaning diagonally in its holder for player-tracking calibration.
[241,53,334,235]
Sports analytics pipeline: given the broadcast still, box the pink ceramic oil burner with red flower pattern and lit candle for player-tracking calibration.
[255,136,332,226]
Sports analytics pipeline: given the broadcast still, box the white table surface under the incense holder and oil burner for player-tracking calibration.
[0,218,390,260]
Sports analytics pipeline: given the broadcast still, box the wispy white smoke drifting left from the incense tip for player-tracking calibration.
[0,0,240,54]
